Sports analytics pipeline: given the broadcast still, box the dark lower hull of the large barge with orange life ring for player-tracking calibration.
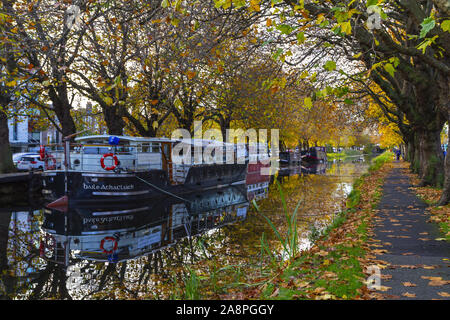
[43,164,247,205]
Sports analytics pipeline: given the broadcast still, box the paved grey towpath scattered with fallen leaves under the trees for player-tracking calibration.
[373,163,450,300]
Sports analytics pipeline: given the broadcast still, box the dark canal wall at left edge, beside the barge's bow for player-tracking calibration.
[0,171,42,207]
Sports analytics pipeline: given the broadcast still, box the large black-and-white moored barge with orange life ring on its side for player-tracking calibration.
[41,135,247,205]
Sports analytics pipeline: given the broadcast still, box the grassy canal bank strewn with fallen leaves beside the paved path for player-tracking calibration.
[253,153,393,300]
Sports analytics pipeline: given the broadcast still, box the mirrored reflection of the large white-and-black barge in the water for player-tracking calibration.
[40,185,249,266]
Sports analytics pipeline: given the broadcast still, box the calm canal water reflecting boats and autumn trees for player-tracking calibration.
[0,157,370,300]
